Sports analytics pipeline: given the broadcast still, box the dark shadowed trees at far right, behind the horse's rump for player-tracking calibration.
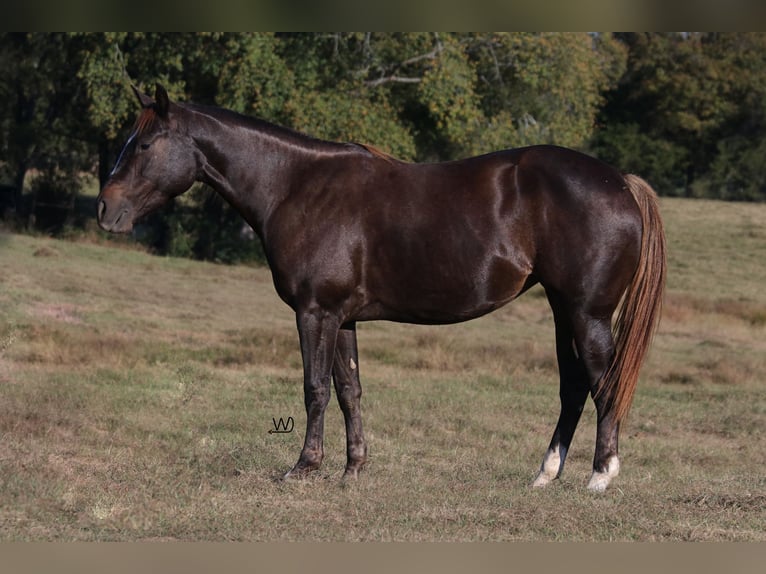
[592,33,766,198]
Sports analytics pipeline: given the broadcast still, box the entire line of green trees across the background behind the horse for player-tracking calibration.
[0,32,766,261]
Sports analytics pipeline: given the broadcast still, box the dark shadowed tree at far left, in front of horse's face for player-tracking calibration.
[0,33,93,226]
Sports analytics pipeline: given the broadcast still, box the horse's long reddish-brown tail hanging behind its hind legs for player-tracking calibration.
[599,174,667,422]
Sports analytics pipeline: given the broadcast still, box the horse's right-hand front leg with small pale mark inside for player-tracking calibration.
[332,323,367,478]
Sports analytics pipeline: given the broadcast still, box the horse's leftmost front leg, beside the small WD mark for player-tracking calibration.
[284,309,340,478]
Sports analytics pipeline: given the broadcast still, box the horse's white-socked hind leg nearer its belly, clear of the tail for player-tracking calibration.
[532,291,590,487]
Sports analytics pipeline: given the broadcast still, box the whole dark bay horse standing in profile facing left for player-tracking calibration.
[98,85,666,491]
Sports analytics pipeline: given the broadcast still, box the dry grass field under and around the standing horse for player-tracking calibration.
[0,200,766,541]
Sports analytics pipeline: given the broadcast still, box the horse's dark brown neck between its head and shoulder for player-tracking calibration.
[184,106,338,239]
